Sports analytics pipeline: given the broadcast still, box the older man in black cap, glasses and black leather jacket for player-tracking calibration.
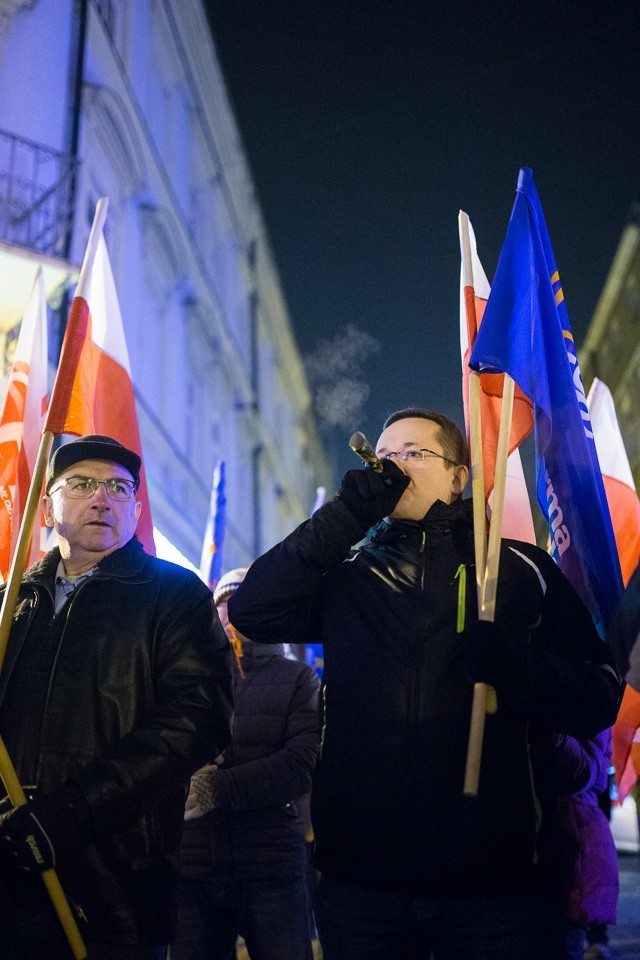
[0,436,232,960]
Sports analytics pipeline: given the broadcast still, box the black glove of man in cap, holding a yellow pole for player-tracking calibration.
[0,784,85,873]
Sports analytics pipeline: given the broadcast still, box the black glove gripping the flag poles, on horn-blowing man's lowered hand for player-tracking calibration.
[462,620,527,696]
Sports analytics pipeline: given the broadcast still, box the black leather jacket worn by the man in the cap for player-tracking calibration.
[0,538,232,944]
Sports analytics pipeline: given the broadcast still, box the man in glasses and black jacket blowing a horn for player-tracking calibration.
[229,408,619,960]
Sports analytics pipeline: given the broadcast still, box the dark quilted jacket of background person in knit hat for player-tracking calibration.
[181,643,320,880]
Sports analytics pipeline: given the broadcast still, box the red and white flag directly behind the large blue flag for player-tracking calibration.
[460,215,536,543]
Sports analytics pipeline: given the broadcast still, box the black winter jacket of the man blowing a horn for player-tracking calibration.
[229,499,619,897]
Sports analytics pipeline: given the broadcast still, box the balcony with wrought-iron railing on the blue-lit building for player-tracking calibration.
[0,130,78,257]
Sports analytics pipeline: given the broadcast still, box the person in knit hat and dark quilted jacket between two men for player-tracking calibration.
[171,568,320,960]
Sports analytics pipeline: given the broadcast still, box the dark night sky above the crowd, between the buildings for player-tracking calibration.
[209,0,640,476]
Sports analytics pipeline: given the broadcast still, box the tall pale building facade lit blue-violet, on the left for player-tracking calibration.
[0,0,333,567]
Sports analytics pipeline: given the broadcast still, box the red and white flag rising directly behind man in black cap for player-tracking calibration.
[45,235,155,554]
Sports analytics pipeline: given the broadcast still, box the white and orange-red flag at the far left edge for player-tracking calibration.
[0,267,47,582]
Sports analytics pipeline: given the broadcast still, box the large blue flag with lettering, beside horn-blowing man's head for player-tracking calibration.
[469,169,622,635]
